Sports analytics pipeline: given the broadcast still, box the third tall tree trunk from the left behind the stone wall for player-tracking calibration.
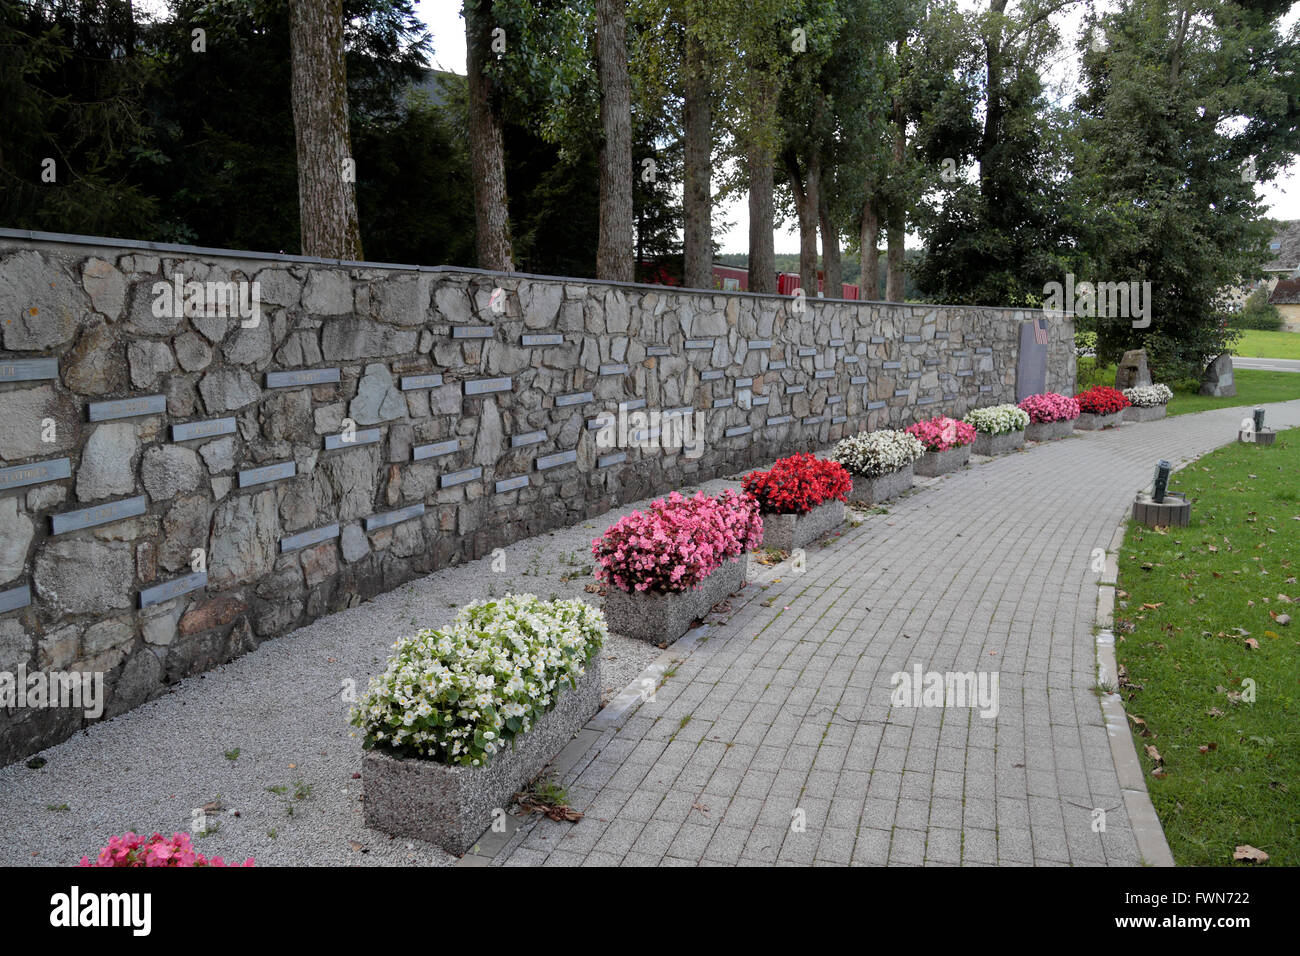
[595,0,636,282]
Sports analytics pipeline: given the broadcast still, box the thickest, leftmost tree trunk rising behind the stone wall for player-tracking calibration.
[289,0,361,259]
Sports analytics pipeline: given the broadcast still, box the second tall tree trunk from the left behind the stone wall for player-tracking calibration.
[464,0,515,272]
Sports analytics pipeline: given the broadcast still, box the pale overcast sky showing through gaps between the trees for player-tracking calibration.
[416,0,1300,252]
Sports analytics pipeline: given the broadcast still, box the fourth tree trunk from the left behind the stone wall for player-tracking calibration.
[683,23,714,289]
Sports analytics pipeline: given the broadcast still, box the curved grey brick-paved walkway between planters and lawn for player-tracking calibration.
[495,402,1300,866]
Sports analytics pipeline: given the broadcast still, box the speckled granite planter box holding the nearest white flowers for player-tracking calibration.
[361,658,601,856]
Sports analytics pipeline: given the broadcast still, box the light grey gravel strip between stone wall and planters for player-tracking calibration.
[0,463,759,866]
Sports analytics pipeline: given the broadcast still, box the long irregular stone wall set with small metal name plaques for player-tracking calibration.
[0,230,1075,762]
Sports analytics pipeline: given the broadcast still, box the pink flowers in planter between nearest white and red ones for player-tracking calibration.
[592,490,763,593]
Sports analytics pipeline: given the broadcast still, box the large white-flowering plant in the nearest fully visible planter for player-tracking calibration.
[351,594,606,766]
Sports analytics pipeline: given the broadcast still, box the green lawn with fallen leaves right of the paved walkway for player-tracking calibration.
[1115,431,1300,866]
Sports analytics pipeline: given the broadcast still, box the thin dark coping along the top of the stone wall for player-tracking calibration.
[0,226,1044,313]
